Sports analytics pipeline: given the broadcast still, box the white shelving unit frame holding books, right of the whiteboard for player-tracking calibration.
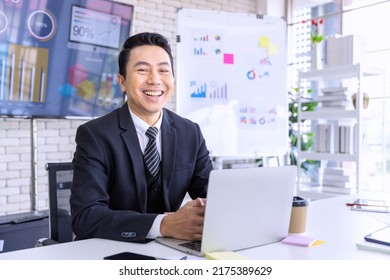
[297,64,381,196]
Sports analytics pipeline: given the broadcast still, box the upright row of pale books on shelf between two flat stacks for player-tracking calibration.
[314,120,356,155]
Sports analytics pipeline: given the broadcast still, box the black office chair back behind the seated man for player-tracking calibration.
[36,162,74,247]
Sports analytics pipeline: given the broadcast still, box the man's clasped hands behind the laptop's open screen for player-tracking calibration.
[160,198,206,240]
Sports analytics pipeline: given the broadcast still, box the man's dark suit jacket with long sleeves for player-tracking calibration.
[70,104,212,242]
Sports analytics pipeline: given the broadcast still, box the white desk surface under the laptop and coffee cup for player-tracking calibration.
[0,195,390,260]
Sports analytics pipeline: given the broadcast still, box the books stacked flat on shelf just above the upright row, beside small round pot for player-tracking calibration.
[318,87,351,109]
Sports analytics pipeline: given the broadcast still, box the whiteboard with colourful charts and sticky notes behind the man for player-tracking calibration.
[176,9,289,157]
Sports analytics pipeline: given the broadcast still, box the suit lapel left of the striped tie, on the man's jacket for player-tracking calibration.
[119,103,147,213]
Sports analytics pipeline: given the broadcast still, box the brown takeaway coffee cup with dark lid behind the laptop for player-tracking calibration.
[288,196,309,233]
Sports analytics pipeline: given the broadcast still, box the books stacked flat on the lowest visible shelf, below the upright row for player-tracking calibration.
[322,167,356,194]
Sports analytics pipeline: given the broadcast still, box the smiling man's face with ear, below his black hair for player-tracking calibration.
[118,45,174,125]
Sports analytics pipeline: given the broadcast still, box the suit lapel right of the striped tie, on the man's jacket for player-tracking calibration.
[161,110,177,211]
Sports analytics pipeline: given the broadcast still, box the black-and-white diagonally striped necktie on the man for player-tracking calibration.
[144,126,160,177]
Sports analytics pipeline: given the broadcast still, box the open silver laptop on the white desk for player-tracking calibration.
[156,166,297,256]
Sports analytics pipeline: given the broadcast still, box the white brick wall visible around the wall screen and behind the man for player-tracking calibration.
[0,0,256,215]
